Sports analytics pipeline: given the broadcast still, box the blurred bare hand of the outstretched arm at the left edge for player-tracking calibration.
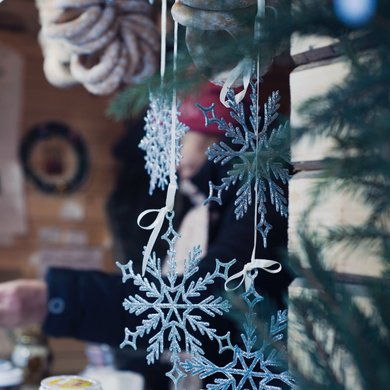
[0,279,47,328]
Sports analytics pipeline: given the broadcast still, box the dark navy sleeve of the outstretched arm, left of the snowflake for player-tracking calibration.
[44,268,130,346]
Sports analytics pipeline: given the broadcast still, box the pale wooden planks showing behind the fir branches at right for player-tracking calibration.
[288,36,382,390]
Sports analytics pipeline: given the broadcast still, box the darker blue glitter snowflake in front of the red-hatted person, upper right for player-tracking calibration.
[198,82,290,247]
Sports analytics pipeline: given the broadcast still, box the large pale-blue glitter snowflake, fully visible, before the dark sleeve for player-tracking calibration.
[116,212,235,388]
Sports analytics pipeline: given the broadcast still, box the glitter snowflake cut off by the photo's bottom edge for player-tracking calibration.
[182,283,296,390]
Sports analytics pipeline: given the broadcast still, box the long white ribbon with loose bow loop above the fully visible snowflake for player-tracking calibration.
[137,9,178,276]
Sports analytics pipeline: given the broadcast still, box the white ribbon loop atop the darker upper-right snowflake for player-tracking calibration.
[219,57,253,108]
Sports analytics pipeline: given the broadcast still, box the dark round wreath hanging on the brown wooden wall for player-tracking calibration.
[19,121,89,194]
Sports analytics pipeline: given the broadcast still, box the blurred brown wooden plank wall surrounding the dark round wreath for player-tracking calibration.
[0,0,122,373]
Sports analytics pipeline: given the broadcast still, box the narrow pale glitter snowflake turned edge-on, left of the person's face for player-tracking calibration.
[139,93,188,195]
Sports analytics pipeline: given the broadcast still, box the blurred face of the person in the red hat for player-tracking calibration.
[178,131,219,180]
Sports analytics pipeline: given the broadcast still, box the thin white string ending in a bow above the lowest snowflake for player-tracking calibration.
[225,0,282,291]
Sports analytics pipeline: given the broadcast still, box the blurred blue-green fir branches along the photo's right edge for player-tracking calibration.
[269,0,390,390]
